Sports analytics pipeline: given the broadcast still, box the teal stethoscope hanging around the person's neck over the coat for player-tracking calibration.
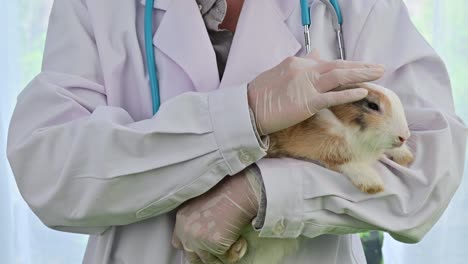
[145,0,346,114]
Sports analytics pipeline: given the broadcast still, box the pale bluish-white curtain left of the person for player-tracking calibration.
[0,0,87,264]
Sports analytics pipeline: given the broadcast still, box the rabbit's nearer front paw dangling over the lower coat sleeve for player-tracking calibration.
[339,162,384,194]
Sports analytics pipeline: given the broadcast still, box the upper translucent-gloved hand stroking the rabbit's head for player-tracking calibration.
[247,50,384,135]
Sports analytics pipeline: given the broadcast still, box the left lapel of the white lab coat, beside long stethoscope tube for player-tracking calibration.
[153,0,219,92]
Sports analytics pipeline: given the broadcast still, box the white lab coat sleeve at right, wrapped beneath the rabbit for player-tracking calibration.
[257,0,467,243]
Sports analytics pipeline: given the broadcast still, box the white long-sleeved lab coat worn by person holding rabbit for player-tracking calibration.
[8,0,467,264]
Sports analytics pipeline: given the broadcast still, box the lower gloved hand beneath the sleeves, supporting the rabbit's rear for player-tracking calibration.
[172,172,259,264]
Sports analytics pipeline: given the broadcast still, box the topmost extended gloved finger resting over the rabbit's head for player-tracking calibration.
[311,68,384,93]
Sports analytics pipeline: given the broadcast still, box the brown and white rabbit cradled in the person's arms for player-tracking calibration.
[231,83,413,264]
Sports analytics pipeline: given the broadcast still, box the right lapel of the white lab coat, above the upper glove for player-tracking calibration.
[221,0,301,87]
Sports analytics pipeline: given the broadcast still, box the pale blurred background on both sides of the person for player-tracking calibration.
[0,0,468,264]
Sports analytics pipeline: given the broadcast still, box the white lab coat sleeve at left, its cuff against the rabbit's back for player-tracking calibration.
[7,0,268,234]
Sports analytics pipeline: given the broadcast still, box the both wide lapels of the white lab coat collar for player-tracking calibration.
[140,0,300,92]
